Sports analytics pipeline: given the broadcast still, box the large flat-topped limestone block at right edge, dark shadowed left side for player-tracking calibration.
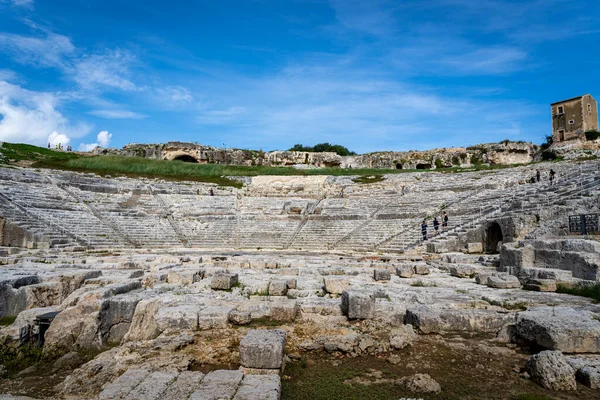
[517,307,600,353]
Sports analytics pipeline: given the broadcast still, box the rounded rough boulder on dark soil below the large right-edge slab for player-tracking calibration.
[525,350,577,390]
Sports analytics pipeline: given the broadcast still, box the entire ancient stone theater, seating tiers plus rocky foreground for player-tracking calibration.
[0,160,600,400]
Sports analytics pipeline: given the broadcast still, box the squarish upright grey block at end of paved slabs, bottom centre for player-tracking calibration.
[240,329,285,369]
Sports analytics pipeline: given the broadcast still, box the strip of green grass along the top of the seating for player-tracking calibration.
[0,142,507,187]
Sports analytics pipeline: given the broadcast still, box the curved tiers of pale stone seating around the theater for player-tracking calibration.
[0,161,600,251]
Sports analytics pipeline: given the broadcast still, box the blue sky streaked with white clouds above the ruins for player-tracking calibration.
[0,0,600,153]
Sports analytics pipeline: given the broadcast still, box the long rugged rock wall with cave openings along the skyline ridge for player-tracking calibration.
[94,142,537,169]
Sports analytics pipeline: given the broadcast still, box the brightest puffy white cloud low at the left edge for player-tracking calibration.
[0,81,90,146]
